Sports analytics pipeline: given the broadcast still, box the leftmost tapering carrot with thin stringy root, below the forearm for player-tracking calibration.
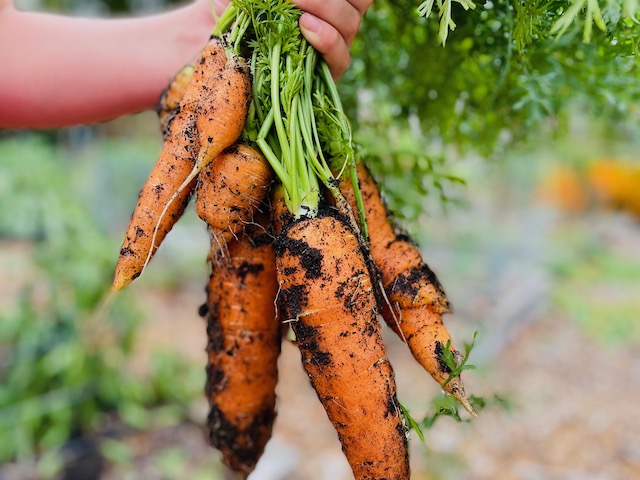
[113,37,250,291]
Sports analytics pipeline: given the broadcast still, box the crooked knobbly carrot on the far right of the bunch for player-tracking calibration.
[340,163,475,414]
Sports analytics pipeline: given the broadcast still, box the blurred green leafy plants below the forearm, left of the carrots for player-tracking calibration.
[0,136,202,468]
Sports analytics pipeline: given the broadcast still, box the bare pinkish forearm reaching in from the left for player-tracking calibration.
[0,5,212,128]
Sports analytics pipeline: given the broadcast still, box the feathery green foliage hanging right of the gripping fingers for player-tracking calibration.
[340,0,640,227]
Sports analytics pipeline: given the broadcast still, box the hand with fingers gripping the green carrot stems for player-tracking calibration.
[196,0,373,80]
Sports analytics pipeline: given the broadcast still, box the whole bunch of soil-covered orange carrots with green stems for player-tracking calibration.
[113,0,474,480]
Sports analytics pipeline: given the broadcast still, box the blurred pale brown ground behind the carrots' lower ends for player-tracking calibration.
[87,276,640,480]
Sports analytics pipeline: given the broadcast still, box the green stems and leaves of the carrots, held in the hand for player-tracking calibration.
[214,0,367,234]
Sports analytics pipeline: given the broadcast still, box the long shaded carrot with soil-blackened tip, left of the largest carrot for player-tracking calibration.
[205,215,281,475]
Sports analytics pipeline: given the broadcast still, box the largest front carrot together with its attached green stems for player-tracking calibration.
[220,0,409,472]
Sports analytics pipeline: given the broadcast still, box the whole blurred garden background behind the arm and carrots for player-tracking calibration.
[0,0,640,480]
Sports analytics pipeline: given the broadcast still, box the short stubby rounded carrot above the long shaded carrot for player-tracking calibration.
[196,144,273,255]
